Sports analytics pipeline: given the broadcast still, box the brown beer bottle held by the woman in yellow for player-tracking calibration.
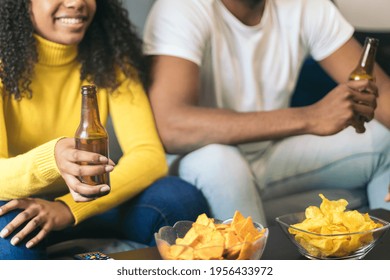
[75,85,110,185]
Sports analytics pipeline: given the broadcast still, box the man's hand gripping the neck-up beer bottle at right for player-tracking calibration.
[308,80,378,136]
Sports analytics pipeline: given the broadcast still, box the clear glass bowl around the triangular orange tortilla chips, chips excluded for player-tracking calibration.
[154,219,269,260]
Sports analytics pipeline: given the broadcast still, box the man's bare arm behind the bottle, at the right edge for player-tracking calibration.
[319,38,390,128]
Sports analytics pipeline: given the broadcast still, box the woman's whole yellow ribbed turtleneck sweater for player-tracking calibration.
[0,36,167,224]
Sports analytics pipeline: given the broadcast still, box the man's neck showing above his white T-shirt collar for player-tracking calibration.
[221,0,267,26]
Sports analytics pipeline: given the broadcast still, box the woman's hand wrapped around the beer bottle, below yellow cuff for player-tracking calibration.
[55,138,115,202]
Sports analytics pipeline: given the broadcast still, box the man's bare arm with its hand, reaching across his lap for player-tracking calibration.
[149,56,370,153]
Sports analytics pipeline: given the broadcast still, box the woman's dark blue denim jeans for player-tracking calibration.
[0,177,209,259]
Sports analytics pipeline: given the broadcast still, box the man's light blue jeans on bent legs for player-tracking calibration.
[168,121,390,224]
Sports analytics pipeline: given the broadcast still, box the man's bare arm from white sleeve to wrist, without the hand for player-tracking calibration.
[149,56,312,153]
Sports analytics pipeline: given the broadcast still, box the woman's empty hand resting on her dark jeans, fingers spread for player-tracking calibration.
[0,198,74,248]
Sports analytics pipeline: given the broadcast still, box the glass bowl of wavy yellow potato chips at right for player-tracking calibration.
[276,194,390,260]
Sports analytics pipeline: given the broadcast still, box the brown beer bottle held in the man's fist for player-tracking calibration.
[349,37,379,133]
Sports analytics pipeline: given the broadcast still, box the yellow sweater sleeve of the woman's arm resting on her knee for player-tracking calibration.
[57,75,168,224]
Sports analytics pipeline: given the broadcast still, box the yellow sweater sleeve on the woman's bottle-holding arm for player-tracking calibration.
[0,92,61,200]
